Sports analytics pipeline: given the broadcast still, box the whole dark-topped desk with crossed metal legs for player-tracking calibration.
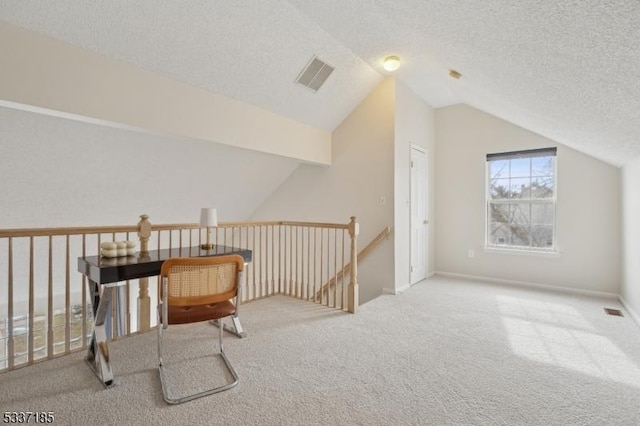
[78,245,253,386]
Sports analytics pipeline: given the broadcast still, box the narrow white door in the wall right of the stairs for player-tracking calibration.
[410,146,429,284]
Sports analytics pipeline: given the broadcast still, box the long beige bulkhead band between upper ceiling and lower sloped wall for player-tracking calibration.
[0,22,331,164]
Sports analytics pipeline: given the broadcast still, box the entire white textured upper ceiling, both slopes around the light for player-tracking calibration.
[0,0,640,165]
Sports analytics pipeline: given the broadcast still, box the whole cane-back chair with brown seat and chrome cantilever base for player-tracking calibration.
[158,255,244,404]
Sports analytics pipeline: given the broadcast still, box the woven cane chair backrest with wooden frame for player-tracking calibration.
[160,255,244,306]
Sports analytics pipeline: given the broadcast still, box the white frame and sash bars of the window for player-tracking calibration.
[484,147,559,255]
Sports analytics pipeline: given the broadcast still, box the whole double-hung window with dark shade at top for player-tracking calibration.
[486,148,556,251]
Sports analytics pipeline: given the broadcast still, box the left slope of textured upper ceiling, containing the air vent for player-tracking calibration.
[0,0,382,130]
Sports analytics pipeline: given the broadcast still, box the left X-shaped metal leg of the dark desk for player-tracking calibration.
[87,280,115,386]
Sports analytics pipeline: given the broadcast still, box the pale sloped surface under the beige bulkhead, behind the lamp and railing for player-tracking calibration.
[0,107,299,228]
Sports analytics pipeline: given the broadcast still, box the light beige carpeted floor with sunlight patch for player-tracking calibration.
[0,277,640,425]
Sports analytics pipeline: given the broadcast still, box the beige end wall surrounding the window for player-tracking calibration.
[436,105,620,294]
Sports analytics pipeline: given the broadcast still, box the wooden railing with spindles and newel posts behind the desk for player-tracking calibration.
[0,215,360,373]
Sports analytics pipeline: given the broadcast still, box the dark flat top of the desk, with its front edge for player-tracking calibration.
[78,245,253,284]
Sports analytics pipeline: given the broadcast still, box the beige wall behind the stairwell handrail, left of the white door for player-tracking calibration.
[251,78,395,303]
